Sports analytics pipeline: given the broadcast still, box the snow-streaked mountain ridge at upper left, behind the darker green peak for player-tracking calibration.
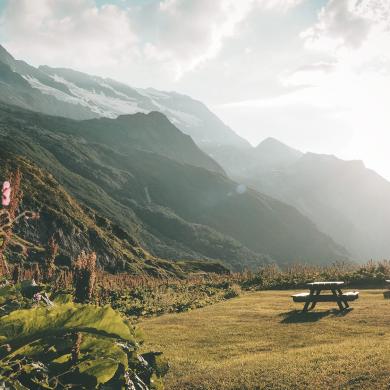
[0,46,249,147]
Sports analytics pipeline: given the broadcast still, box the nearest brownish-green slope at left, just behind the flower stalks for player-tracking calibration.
[0,148,187,276]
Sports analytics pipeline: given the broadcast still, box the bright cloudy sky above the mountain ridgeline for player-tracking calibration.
[0,0,390,178]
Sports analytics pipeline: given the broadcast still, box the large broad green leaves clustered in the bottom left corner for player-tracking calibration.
[0,284,167,390]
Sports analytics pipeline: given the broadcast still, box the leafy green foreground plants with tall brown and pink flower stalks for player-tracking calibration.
[0,171,167,390]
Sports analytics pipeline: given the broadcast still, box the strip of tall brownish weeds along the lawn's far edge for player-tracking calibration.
[11,260,390,317]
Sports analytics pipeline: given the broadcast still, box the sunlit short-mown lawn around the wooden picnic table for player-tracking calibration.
[140,290,390,390]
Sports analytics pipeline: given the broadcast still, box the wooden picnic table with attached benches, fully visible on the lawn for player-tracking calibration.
[292,282,359,312]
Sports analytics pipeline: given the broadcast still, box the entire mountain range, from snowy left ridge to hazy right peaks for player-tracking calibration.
[0,43,390,273]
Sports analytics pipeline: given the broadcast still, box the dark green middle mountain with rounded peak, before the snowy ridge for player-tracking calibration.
[0,104,347,270]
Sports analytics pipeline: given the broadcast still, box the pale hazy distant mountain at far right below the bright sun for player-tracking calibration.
[238,140,390,261]
